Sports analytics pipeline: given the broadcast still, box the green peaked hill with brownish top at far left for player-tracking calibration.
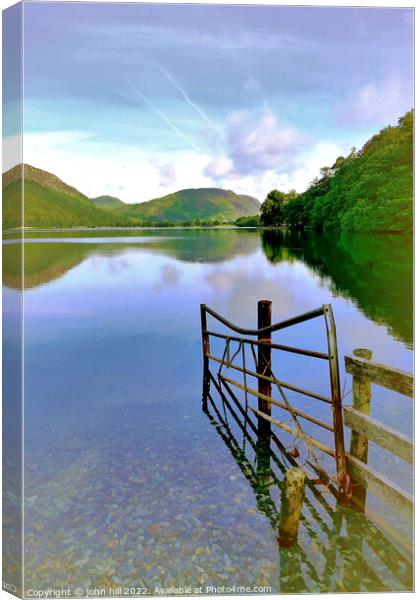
[3,164,129,229]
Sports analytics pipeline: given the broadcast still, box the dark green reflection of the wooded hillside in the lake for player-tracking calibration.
[261,230,413,347]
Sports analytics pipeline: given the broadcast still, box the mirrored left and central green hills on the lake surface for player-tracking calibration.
[3,229,259,289]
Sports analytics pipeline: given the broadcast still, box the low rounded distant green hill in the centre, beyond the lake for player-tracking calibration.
[113,188,260,223]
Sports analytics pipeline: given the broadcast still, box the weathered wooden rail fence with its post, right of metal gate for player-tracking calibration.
[343,348,414,518]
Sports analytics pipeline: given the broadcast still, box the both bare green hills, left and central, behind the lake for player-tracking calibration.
[3,164,260,229]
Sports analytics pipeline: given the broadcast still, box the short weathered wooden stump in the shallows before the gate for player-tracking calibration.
[279,467,306,546]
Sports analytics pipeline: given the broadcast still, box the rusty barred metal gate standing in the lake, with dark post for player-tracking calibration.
[200,300,351,499]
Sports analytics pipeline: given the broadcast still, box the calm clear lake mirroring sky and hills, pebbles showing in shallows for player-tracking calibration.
[3,229,413,593]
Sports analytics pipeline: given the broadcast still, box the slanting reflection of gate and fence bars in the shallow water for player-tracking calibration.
[203,378,413,593]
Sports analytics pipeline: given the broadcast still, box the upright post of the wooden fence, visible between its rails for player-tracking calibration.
[350,348,373,511]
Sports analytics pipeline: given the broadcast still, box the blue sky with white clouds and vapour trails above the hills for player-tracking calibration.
[4,3,413,202]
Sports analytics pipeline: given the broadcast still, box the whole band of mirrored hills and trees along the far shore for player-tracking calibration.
[3,229,413,348]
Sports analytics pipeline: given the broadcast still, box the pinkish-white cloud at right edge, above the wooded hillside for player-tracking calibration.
[336,75,413,126]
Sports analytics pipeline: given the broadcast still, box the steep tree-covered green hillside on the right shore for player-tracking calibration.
[278,111,413,231]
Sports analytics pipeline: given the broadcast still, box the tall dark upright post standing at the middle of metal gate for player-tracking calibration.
[257,300,272,434]
